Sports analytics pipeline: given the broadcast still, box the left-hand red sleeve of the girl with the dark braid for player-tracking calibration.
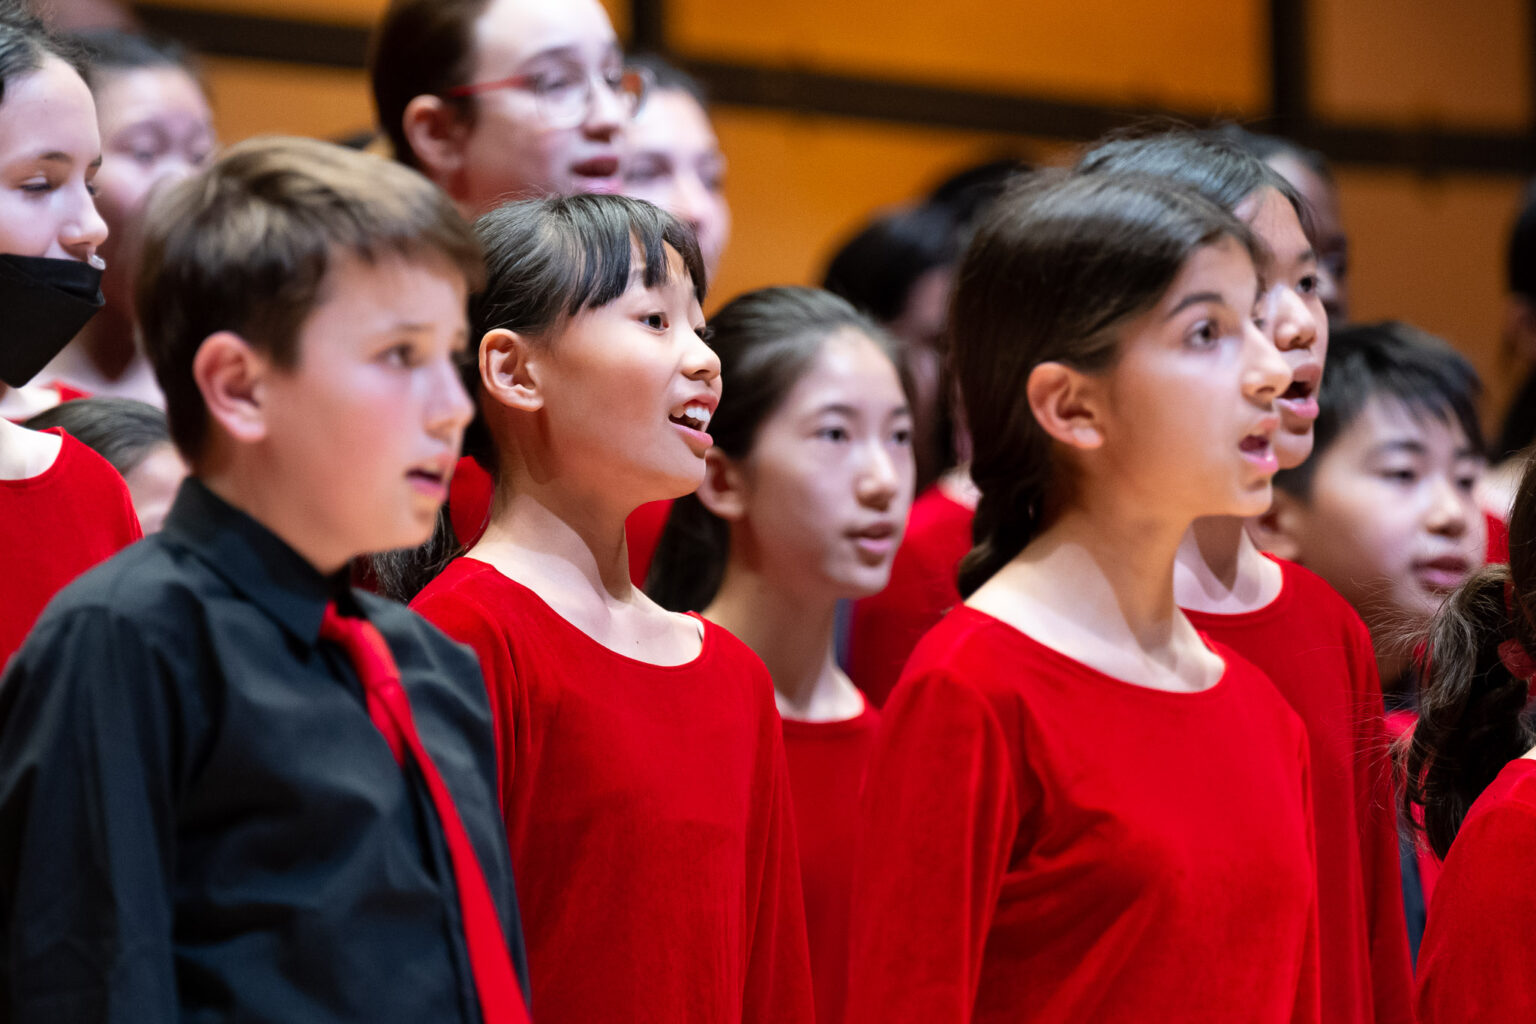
[846,671,1020,1024]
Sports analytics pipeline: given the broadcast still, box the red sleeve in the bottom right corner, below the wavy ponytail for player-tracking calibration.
[1418,804,1536,1024]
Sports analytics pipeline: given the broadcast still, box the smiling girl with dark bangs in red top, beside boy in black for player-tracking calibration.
[386,195,813,1024]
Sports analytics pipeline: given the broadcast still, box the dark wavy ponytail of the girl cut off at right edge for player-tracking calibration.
[1406,454,1536,857]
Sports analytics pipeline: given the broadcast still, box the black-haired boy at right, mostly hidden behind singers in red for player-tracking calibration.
[1253,322,1487,955]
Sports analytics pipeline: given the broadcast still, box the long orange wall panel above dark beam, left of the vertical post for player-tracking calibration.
[668,0,1269,114]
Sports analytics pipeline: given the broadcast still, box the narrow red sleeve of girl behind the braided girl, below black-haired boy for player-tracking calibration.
[1349,616,1413,1024]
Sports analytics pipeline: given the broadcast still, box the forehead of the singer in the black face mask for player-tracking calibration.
[0,57,101,156]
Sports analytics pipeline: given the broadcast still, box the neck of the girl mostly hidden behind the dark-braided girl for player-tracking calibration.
[1174,516,1283,616]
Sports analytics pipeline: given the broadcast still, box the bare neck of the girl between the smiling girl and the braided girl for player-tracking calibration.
[703,559,863,722]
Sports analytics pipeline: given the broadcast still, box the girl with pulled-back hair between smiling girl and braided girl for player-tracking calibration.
[650,287,915,1024]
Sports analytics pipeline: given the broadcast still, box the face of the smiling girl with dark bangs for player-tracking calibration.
[533,247,720,508]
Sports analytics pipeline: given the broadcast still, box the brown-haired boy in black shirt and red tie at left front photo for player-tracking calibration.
[0,138,527,1024]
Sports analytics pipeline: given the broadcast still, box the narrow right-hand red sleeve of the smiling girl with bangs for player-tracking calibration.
[742,721,816,1024]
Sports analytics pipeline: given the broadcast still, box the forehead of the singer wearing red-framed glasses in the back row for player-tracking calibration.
[475,0,619,72]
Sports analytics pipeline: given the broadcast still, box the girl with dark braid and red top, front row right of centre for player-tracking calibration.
[848,175,1319,1024]
